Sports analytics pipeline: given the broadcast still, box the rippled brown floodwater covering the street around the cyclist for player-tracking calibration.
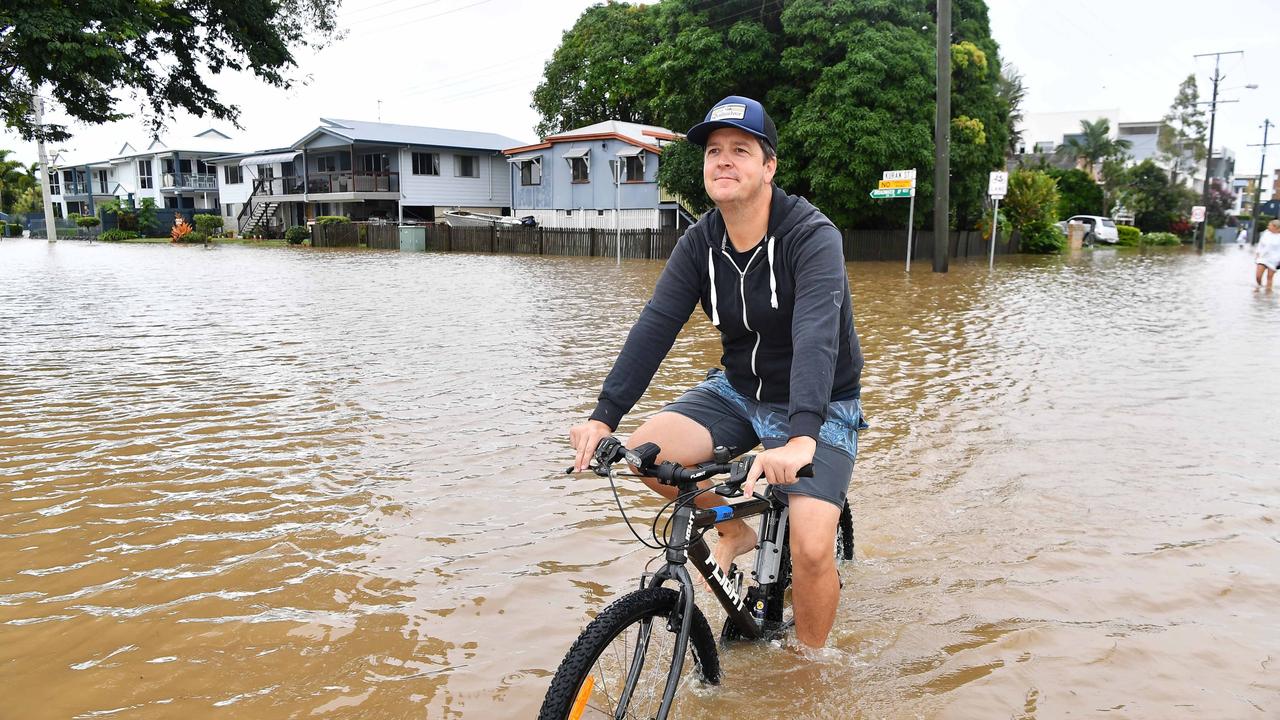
[0,241,1280,720]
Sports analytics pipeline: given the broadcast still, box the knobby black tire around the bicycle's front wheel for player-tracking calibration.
[538,588,719,720]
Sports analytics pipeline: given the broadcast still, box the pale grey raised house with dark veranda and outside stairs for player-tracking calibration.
[214,118,520,233]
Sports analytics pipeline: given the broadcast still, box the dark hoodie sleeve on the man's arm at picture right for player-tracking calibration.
[787,224,849,439]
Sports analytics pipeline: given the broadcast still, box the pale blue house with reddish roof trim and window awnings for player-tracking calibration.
[503,120,692,229]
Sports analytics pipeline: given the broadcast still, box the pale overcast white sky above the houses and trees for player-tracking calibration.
[10,0,1280,196]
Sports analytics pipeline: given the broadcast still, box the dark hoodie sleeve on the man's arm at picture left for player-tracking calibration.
[591,232,701,429]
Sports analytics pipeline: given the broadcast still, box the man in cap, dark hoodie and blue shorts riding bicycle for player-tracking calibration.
[570,95,865,647]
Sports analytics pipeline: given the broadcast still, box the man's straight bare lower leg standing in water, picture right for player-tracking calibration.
[787,495,840,648]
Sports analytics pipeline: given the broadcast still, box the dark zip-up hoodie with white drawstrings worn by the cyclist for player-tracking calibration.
[591,186,863,438]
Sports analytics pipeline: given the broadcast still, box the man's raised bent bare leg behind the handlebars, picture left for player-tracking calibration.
[627,413,757,573]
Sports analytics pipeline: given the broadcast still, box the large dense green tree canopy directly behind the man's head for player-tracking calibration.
[532,0,1011,227]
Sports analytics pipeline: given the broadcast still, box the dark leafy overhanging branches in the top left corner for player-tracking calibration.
[0,0,339,141]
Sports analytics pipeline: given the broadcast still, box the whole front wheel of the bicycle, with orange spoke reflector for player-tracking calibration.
[538,588,719,720]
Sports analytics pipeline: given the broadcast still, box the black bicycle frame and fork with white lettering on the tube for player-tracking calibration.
[622,474,787,720]
